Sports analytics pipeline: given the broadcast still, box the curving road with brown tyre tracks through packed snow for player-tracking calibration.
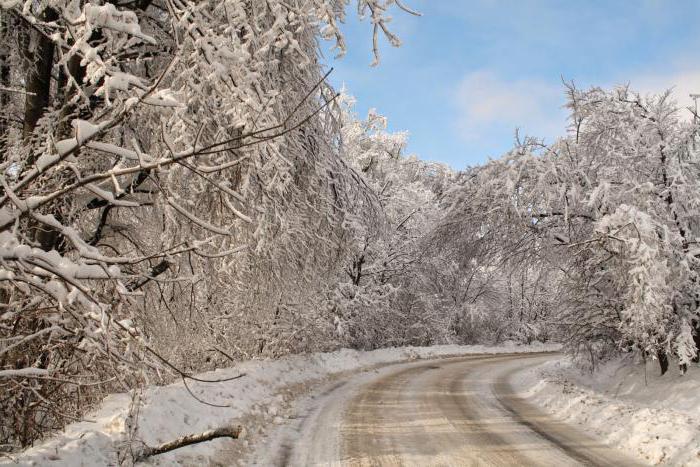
[281,354,639,467]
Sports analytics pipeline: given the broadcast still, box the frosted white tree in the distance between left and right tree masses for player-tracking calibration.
[331,97,452,348]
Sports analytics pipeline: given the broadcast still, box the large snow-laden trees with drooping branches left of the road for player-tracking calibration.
[0,0,416,446]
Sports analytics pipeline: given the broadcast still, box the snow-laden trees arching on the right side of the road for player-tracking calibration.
[438,85,700,373]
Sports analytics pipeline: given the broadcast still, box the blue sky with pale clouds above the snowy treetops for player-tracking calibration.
[325,0,700,169]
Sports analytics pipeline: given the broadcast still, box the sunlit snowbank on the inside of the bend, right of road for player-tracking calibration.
[512,356,700,466]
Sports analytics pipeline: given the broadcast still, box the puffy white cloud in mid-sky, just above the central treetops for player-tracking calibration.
[455,70,566,142]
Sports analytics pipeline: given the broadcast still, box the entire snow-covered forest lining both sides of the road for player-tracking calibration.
[0,0,700,451]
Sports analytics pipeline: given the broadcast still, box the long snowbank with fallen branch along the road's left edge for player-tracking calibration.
[0,344,559,467]
